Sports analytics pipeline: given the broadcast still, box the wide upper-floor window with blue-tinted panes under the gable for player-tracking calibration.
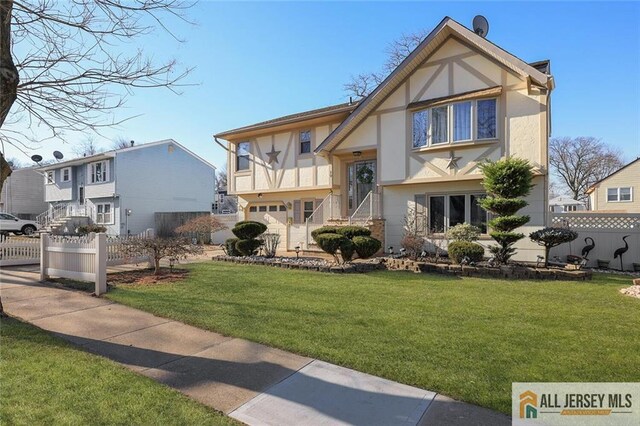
[412,98,497,148]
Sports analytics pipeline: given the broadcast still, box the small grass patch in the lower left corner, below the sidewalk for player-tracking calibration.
[0,318,234,425]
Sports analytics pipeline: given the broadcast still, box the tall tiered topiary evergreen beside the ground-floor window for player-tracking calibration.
[480,157,534,264]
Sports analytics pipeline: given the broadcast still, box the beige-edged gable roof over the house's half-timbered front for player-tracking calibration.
[314,16,553,153]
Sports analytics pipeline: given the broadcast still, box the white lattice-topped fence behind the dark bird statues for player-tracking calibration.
[550,212,640,271]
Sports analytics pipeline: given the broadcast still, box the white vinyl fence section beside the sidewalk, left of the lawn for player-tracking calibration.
[40,231,153,295]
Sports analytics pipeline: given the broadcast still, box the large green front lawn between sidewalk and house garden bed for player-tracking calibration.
[108,263,640,413]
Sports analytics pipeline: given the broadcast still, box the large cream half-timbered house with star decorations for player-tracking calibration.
[215,18,554,261]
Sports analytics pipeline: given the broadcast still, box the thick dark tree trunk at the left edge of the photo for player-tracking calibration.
[0,0,20,200]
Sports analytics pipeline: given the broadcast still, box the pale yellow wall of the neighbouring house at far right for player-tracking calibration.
[590,161,640,213]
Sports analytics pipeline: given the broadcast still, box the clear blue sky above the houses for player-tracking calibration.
[7,1,640,170]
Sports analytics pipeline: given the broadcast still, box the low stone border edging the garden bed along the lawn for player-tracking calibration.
[212,256,592,281]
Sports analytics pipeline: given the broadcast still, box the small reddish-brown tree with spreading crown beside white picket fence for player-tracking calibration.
[124,238,204,275]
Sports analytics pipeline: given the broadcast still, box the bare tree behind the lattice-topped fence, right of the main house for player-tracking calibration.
[549,136,624,200]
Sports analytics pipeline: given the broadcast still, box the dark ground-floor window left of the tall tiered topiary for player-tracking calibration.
[428,194,487,234]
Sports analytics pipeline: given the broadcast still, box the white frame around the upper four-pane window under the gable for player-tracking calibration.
[407,96,500,151]
